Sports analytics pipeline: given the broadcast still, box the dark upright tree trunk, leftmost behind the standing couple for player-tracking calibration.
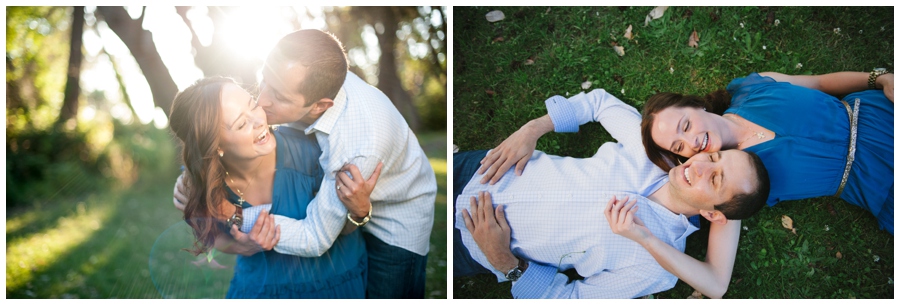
[56,6,84,125]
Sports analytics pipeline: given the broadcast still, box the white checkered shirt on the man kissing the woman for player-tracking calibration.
[275,72,437,256]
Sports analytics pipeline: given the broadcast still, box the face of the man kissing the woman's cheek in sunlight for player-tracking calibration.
[259,60,321,125]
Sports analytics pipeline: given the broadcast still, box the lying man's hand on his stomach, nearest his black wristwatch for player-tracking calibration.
[463,192,519,272]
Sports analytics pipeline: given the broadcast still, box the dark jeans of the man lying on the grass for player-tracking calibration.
[454,150,491,277]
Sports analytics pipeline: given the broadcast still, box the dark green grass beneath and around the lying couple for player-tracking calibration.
[453,7,894,299]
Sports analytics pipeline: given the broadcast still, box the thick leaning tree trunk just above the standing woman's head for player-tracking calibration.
[97,6,178,116]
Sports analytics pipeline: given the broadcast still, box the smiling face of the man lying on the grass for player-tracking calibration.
[669,149,758,211]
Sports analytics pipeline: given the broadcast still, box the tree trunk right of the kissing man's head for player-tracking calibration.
[371,7,421,131]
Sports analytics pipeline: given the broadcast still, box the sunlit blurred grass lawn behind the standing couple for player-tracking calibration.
[6,127,447,298]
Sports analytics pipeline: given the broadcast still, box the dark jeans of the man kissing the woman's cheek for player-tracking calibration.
[363,232,428,299]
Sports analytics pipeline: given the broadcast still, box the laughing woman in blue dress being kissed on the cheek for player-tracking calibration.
[170,77,377,298]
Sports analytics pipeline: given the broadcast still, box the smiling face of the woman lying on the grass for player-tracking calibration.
[650,107,725,158]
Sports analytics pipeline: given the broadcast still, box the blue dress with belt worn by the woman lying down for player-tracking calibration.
[725,73,894,234]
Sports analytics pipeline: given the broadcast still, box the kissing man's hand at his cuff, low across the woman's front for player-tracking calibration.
[231,210,281,256]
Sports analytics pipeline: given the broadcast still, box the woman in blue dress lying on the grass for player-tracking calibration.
[641,69,894,235]
